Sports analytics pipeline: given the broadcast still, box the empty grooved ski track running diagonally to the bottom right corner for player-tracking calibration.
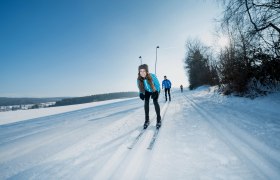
[184,93,280,179]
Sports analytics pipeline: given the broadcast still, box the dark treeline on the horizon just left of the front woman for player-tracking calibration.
[54,92,138,106]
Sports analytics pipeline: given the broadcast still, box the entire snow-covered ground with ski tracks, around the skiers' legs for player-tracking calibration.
[0,87,280,180]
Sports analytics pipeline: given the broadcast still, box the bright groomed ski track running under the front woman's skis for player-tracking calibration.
[94,102,169,179]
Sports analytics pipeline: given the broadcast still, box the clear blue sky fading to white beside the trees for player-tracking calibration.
[0,0,221,97]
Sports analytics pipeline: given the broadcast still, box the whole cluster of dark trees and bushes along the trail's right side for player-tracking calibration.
[185,0,280,97]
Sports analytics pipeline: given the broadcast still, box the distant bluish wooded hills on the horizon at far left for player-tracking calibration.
[0,97,63,106]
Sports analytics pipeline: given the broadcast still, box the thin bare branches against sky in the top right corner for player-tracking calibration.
[222,0,280,56]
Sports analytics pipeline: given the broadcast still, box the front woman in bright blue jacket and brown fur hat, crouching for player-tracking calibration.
[137,64,161,129]
